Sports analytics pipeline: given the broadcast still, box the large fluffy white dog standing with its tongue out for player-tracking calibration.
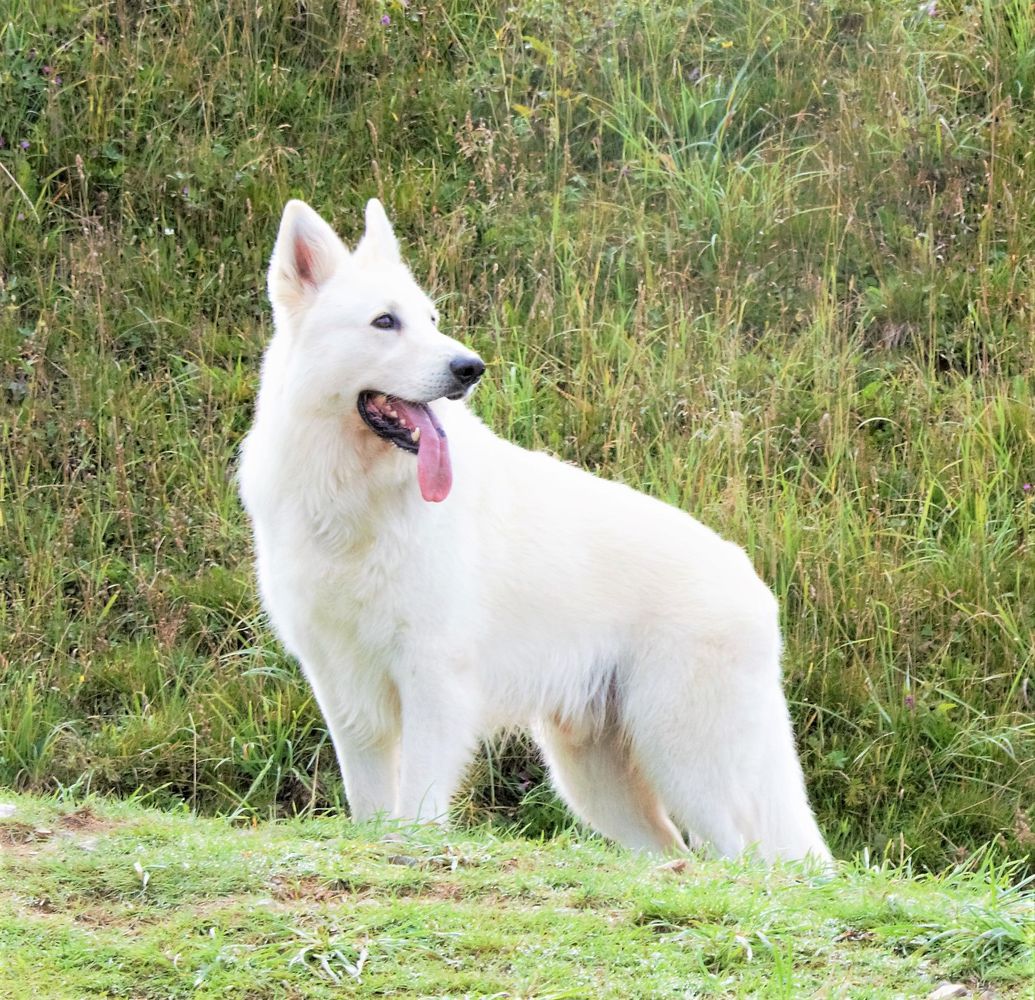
[240,201,830,860]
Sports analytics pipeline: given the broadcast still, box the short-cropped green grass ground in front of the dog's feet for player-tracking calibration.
[0,795,1035,1000]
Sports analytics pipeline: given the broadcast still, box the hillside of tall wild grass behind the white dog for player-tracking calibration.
[0,0,1035,867]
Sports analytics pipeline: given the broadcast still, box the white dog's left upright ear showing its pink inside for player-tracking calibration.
[266,199,349,311]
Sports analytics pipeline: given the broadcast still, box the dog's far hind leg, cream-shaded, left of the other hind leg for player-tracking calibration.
[535,722,686,854]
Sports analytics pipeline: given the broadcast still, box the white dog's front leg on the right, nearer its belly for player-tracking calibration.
[395,676,479,823]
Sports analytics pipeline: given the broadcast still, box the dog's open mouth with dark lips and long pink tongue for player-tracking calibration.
[357,392,452,503]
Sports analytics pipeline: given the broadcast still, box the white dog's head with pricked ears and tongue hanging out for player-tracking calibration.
[268,199,485,500]
